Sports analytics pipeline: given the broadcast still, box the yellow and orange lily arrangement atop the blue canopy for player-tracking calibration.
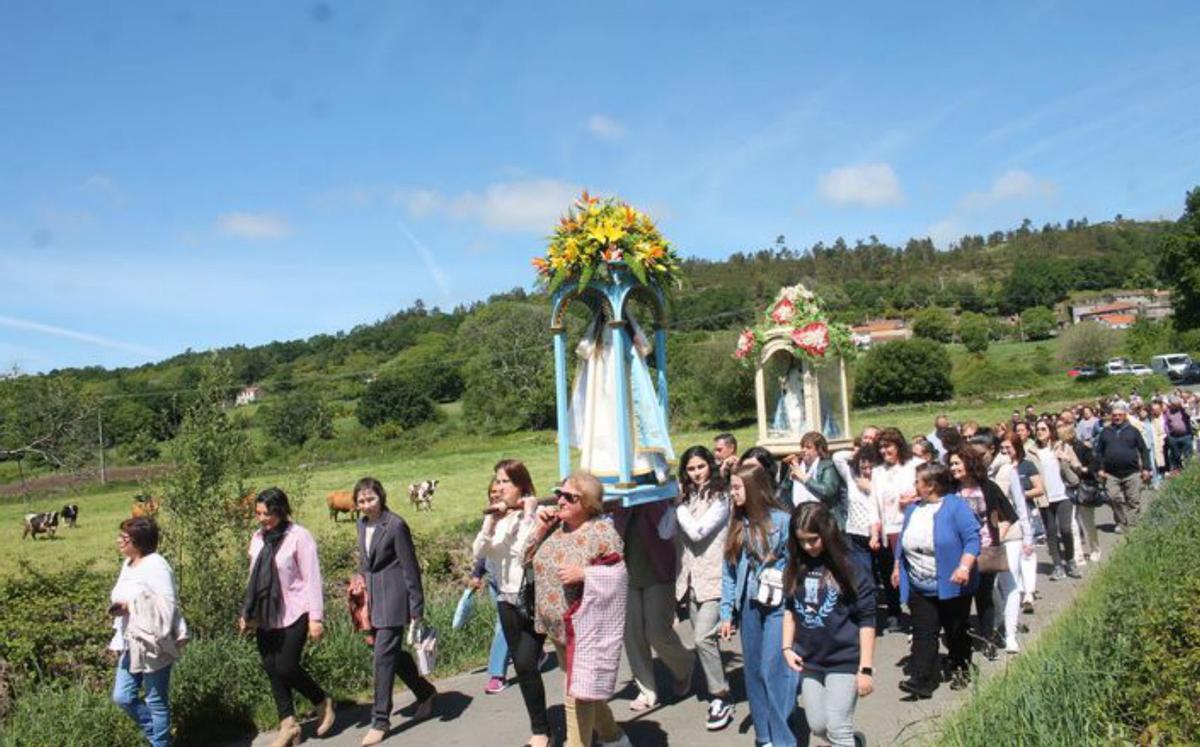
[533,190,679,293]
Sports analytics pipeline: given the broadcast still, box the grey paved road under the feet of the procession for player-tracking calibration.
[230,504,1132,747]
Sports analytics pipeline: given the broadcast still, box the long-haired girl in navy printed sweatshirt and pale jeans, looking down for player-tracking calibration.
[784,503,875,747]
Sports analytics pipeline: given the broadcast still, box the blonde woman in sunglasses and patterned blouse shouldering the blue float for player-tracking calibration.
[530,472,631,747]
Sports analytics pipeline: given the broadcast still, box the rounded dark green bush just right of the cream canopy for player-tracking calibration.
[854,339,954,407]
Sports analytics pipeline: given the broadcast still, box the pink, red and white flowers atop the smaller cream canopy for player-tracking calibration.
[733,285,854,365]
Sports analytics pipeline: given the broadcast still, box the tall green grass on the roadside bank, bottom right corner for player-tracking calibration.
[937,465,1200,746]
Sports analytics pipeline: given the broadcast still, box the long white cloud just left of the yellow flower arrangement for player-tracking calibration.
[396,179,581,233]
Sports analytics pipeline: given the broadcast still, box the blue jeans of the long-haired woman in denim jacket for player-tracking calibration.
[742,602,799,747]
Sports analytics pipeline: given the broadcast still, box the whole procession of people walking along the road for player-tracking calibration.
[100,392,1200,747]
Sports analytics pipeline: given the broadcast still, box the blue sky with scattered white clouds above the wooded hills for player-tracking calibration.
[0,1,1200,371]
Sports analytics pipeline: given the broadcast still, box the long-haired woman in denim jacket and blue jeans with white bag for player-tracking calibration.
[721,465,797,747]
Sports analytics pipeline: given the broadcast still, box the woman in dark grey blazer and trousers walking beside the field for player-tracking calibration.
[354,477,438,745]
